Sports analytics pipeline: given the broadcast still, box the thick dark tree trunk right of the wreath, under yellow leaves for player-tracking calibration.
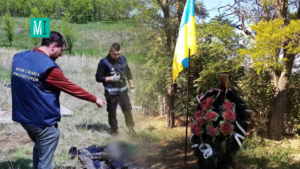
[268,51,295,140]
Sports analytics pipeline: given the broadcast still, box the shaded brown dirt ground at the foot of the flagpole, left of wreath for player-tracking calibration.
[123,117,196,169]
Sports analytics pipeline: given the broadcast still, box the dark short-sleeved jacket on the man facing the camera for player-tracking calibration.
[96,54,132,95]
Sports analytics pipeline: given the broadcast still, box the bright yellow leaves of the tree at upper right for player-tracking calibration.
[239,19,300,73]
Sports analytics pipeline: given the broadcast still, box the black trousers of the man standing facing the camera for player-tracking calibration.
[105,91,134,129]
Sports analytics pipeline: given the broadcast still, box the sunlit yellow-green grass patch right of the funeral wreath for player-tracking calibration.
[236,134,300,169]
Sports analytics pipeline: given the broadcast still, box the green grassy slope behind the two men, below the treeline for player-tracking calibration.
[0,17,137,61]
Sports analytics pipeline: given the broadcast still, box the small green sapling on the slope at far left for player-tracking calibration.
[3,12,15,46]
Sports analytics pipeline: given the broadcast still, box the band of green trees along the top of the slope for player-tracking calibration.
[0,0,138,24]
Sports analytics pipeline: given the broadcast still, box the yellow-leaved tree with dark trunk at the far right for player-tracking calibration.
[220,0,300,140]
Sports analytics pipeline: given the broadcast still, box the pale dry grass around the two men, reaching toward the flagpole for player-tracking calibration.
[0,48,192,169]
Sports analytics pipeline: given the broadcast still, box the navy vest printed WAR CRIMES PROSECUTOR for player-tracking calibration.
[11,50,61,126]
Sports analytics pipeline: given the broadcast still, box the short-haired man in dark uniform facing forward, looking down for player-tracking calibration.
[96,43,135,134]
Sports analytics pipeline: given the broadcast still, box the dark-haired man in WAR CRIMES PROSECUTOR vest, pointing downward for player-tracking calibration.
[11,31,105,169]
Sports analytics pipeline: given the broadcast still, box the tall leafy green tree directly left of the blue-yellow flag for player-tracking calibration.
[136,0,206,127]
